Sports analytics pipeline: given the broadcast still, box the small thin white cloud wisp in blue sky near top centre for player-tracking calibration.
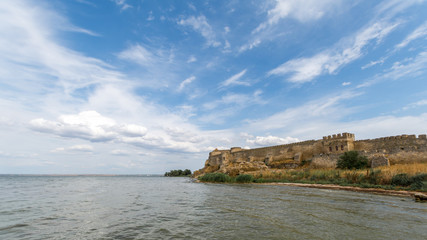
[178,15,221,47]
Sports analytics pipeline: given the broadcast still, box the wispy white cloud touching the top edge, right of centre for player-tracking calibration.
[254,0,341,32]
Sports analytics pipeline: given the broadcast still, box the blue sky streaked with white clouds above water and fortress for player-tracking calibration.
[0,0,427,174]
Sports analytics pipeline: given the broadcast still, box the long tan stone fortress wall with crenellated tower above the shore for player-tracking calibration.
[194,133,427,176]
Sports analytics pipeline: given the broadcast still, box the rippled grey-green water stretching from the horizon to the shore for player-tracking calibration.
[0,176,427,239]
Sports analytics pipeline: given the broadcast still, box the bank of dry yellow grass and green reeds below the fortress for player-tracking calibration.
[199,163,427,192]
